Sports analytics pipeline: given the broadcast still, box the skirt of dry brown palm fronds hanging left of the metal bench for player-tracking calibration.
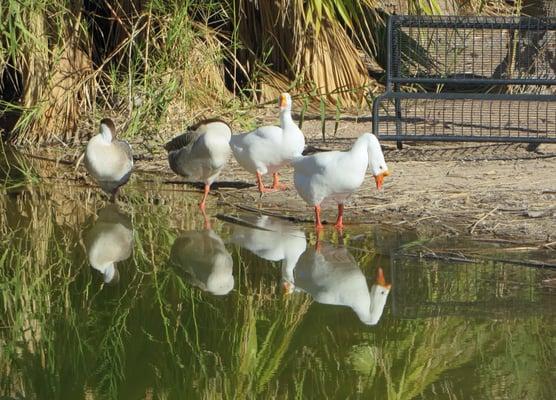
[236,0,382,107]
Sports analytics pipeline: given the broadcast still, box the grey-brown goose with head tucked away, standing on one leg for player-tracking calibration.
[164,119,232,211]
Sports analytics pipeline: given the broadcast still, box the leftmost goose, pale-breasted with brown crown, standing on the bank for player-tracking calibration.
[85,118,133,202]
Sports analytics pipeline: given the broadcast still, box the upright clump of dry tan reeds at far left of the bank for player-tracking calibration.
[13,4,91,143]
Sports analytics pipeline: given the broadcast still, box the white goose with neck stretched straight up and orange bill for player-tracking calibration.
[230,93,305,193]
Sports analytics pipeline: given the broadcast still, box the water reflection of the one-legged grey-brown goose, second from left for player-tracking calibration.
[170,229,234,296]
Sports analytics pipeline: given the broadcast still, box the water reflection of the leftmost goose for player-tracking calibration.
[85,204,133,284]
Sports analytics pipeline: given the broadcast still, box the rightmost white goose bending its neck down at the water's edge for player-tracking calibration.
[292,133,390,229]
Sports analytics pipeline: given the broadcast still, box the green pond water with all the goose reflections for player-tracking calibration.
[0,151,556,399]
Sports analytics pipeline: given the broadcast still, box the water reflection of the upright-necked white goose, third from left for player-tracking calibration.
[232,215,307,274]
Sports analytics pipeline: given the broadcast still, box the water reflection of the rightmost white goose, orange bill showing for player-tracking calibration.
[282,243,391,325]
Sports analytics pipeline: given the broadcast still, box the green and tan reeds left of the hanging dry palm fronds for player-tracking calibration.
[0,0,237,144]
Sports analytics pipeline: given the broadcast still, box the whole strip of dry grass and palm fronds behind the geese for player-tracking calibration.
[0,0,466,144]
